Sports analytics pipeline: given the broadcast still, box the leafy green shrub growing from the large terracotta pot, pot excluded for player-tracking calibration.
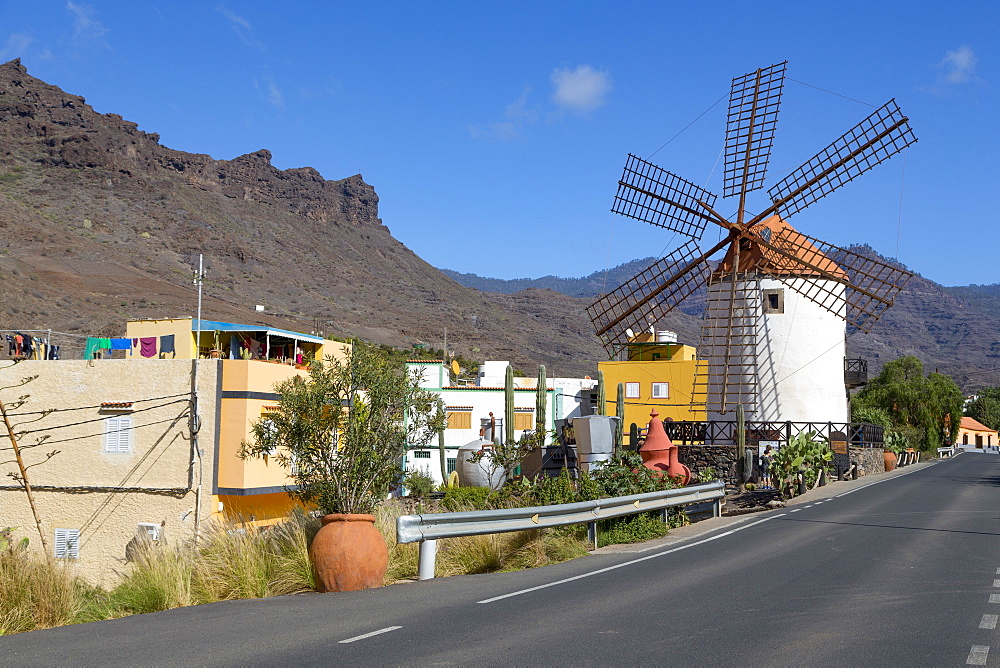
[240,344,443,514]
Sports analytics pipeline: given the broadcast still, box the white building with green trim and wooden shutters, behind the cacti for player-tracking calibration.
[404,360,597,482]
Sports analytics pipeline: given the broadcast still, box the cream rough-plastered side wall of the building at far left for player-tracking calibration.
[0,359,217,586]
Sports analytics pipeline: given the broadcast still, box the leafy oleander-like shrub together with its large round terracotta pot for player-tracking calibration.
[240,345,443,591]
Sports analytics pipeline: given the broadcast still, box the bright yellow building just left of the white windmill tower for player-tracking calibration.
[597,333,706,434]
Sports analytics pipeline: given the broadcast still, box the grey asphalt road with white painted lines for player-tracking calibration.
[0,453,1000,666]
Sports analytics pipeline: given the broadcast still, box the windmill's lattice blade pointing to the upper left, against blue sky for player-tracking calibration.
[611,153,718,239]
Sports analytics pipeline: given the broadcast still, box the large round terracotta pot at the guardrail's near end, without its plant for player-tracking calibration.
[309,513,389,592]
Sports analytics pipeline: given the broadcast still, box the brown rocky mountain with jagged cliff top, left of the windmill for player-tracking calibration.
[0,60,603,375]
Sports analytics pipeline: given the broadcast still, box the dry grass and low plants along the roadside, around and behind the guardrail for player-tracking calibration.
[0,453,683,635]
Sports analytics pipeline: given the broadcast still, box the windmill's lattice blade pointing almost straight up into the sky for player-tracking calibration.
[722,62,787,200]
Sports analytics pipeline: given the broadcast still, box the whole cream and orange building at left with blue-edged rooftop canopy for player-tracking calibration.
[0,318,348,584]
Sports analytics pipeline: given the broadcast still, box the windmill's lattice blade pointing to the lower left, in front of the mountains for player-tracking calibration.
[587,240,721,358]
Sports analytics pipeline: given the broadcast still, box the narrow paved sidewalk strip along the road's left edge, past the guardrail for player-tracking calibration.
[590,459,941,554]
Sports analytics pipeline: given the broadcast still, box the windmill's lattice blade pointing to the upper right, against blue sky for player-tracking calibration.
[748,100,917,225]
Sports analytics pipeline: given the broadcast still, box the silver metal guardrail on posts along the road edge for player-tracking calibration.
[396,480,726,580]
